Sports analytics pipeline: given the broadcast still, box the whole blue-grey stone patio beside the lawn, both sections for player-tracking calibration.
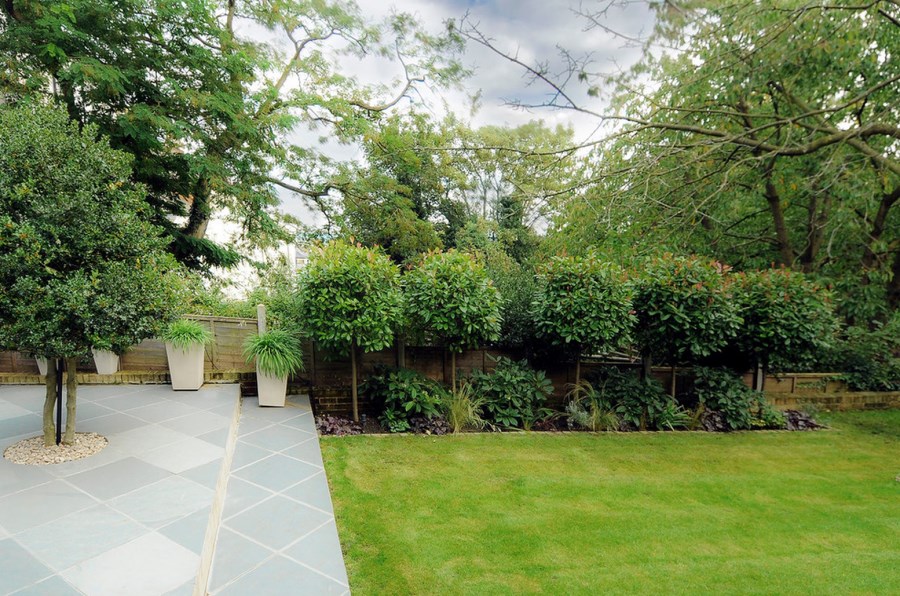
[0,385,348,596]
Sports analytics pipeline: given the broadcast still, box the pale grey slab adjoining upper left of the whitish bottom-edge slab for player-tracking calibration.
[16,505,147,571]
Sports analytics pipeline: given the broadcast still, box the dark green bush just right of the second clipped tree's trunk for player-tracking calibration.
[469,357,553,430]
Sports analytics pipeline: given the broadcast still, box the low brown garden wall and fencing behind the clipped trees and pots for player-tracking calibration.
[0,316,900,415]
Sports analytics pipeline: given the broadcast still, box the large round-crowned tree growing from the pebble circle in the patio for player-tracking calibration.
[0,105,180,445]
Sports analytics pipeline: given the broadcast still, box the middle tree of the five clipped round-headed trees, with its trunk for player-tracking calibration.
[534,255,635,386]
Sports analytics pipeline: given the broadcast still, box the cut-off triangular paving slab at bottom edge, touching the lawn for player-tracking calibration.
[214,556,347,596]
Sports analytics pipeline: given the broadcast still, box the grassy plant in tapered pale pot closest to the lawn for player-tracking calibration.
[244,329,303,407]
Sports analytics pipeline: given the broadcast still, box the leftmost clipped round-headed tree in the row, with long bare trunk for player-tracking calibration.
[293,240,403,421]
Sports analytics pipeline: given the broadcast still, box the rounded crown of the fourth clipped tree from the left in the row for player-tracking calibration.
[634,255,741,363]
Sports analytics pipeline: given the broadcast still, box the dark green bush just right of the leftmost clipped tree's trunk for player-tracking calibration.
[360,367,444,432]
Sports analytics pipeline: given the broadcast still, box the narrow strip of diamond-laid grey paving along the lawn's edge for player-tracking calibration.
[208,396,349,596]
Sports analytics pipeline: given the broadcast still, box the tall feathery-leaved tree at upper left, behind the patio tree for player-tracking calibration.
[0,0,462,268]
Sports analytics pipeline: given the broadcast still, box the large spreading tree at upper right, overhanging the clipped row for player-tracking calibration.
[462,0,900,320]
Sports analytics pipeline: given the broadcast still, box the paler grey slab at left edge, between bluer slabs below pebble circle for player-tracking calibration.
[0,479,97,535]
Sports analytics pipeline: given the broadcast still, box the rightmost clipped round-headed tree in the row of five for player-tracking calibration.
[734,269,837,390]
